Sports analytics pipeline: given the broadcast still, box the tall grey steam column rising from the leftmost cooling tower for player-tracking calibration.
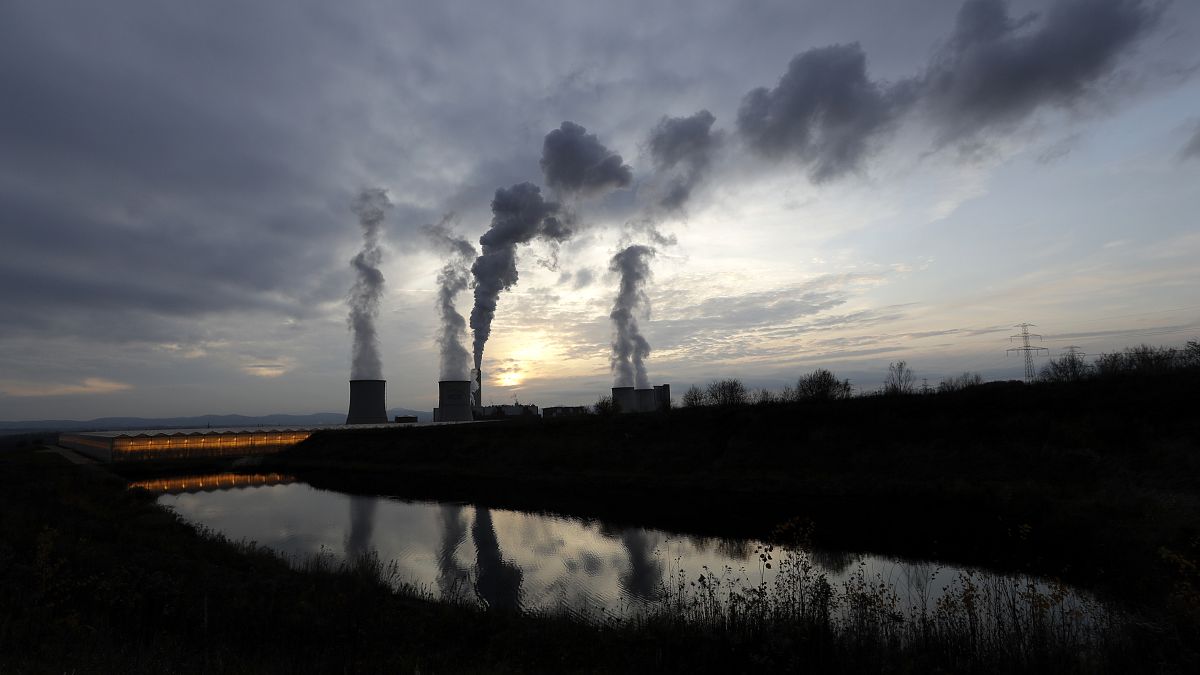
[347,187,391,380]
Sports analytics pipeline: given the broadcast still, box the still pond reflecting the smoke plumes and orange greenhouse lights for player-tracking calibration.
[139,474,1113,621]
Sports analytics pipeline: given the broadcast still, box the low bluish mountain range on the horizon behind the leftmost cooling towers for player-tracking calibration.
[0,408,433,431]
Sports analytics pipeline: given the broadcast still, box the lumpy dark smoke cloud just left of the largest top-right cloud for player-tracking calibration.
[738,43,911,183]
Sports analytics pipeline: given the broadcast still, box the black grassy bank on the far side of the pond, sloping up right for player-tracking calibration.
[268,370,1200,629]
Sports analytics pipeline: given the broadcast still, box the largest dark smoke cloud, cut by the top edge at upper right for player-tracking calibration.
[920,0,1162,143]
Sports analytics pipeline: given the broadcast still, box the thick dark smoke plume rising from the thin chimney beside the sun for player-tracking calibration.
[470,183,571,369]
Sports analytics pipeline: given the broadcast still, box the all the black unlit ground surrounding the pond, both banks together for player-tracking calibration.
[0,371,1200,673]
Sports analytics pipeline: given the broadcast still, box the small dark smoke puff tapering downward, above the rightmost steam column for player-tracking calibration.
[649,110,724,211]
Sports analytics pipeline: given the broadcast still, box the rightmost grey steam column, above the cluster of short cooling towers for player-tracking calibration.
[608,245,654,389]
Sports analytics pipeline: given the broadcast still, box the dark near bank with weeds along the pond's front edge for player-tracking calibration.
[0,444,1187,673]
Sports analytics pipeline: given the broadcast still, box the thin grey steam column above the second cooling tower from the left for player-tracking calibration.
[421,219,475,381]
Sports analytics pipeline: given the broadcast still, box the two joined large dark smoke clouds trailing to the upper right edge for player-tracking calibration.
[738,0,1165,172]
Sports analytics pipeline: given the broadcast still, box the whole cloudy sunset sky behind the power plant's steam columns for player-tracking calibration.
[0,0,1200,420]
